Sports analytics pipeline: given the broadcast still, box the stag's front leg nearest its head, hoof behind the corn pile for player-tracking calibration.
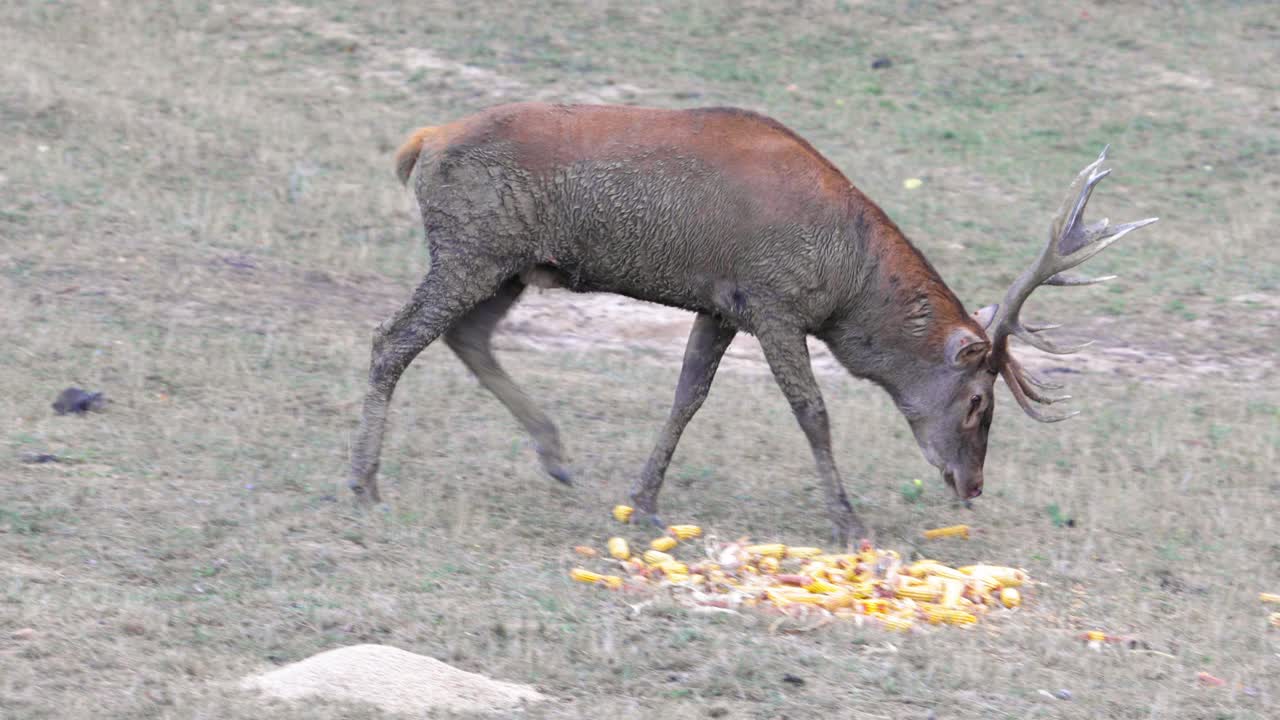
[758,322,865,546]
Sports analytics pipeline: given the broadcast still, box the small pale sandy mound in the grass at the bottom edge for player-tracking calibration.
[241,644,549,715]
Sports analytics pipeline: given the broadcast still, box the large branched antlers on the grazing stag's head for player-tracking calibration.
[987,145,1158,423]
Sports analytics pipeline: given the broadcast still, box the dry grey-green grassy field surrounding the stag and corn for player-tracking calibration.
[0,0,1280,719]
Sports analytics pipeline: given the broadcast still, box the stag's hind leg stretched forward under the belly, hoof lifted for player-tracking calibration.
[444,278,571,484]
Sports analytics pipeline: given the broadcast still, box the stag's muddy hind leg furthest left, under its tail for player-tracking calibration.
[347,252,513,502]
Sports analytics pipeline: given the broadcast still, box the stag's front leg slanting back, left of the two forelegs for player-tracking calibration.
[631,313,737,527]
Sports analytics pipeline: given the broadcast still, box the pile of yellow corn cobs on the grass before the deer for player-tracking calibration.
[570,505,1027,630]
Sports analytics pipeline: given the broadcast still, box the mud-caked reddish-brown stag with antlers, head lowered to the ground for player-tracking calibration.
[349,104,1155,542]
